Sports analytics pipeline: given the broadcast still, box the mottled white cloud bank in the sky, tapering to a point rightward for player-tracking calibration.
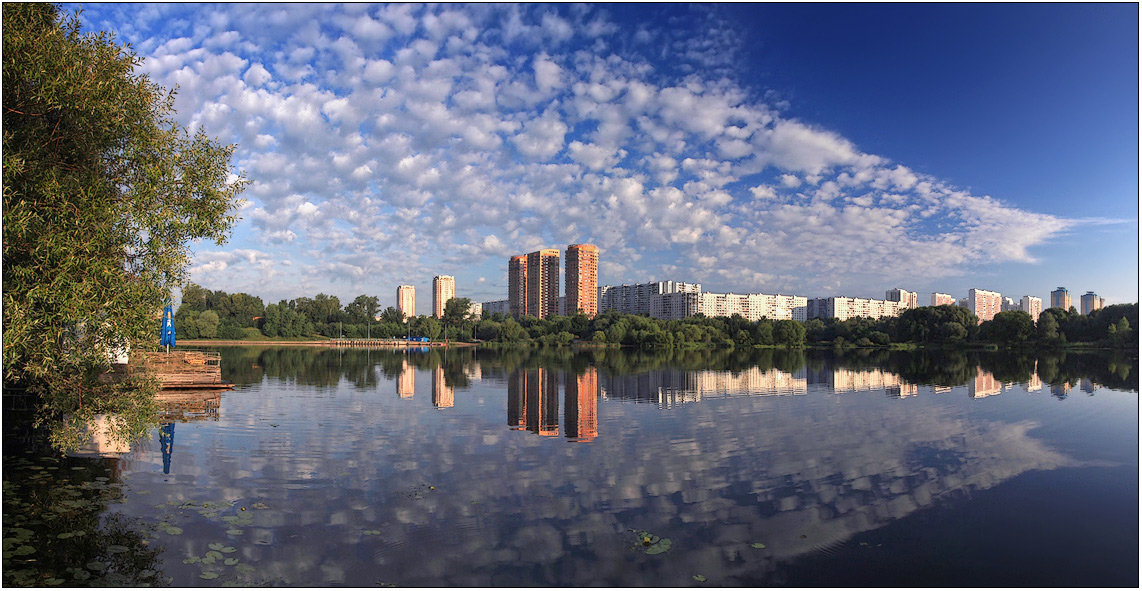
[83,5,1072,303]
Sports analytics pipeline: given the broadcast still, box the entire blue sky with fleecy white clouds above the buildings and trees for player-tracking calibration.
[73,3,1139,314]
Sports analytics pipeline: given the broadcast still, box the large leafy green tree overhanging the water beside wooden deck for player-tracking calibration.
[3,3,246,448]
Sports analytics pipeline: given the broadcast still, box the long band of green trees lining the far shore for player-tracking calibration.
[175,283,1139,351]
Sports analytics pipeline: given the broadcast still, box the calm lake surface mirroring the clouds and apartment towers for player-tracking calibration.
[3,348,1139,586]
